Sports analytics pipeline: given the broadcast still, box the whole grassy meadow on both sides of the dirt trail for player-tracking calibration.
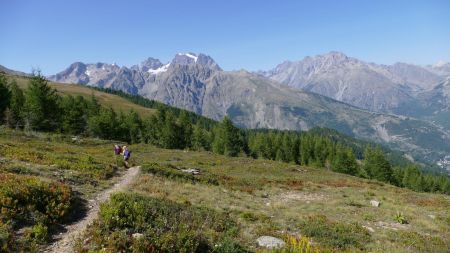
[0,128,450,252]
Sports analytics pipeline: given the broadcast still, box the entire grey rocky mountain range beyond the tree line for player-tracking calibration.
[42,52,450,166]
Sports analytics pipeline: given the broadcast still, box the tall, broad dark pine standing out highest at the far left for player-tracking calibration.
[24,72,61,131]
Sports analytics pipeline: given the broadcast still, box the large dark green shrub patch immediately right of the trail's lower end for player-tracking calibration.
[79,193,244,252]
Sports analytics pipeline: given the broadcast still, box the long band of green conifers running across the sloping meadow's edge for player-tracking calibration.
[0,73,450,194]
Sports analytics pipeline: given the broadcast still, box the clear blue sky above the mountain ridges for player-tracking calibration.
[0,0,450,74]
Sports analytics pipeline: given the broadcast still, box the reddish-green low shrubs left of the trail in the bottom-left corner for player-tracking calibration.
[0,173,73,248]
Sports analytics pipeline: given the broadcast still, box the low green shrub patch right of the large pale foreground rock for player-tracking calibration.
[300,215,371,249]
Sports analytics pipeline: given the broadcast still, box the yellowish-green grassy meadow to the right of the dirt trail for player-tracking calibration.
[128,145,450,252]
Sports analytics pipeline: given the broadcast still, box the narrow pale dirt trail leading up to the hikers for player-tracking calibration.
[43,166,141,253]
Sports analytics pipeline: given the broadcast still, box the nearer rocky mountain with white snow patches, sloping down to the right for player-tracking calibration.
[46,53,450,164]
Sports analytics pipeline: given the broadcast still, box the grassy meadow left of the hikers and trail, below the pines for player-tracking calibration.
[0,128,130,197]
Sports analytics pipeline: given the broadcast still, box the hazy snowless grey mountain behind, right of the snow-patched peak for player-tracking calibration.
[260,52,441,112]
